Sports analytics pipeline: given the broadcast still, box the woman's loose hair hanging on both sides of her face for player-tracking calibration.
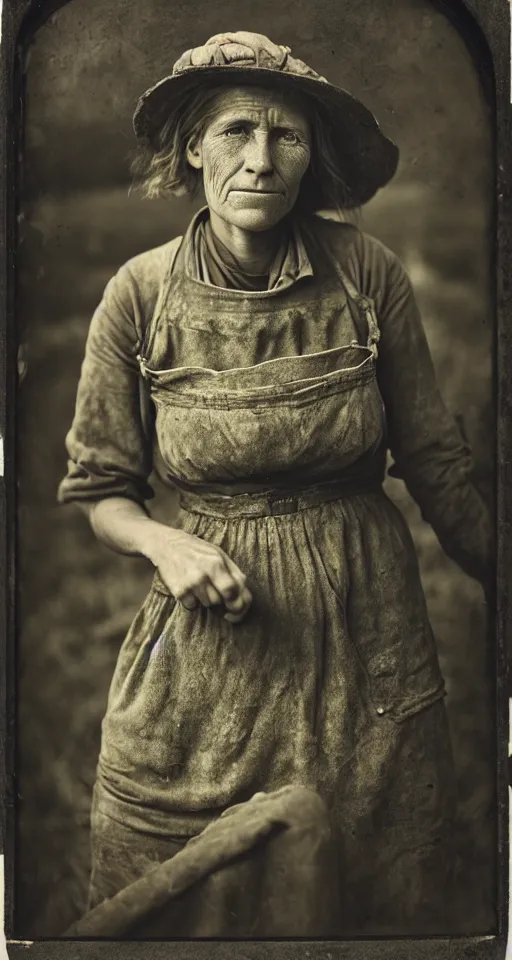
[131,85,353,214]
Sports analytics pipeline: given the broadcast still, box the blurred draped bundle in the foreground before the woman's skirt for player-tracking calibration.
[64,786,339,940]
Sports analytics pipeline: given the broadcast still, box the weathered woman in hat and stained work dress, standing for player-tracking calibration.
[60,33,491,934]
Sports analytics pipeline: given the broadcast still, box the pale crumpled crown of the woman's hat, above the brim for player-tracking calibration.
[173,31,327,82]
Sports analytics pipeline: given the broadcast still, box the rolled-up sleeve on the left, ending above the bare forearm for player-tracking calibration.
[57,265,153,505]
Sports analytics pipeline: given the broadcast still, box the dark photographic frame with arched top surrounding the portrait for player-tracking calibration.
[0,0,512,960]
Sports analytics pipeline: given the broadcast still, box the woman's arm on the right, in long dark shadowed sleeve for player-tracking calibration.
[362,236,494,589]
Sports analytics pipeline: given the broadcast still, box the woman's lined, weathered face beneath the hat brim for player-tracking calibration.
[187,87,311,231]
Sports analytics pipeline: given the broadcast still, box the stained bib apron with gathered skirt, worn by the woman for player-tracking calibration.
[95,223,460,932]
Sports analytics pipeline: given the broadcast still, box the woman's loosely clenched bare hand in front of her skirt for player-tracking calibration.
[150,525,252,623]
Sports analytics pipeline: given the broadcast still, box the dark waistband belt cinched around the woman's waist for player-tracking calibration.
[178,476,383,518]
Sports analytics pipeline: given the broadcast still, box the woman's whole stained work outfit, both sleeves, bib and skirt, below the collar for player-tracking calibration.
[60,212,491,933]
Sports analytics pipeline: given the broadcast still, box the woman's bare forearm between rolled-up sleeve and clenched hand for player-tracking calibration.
[81,497,180,566]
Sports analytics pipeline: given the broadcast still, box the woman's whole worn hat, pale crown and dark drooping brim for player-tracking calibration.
[133,32,398,207]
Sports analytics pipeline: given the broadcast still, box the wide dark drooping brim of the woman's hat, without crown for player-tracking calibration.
[133,64,399,207]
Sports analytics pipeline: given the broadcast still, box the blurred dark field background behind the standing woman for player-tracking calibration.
[15,0,496,939]
